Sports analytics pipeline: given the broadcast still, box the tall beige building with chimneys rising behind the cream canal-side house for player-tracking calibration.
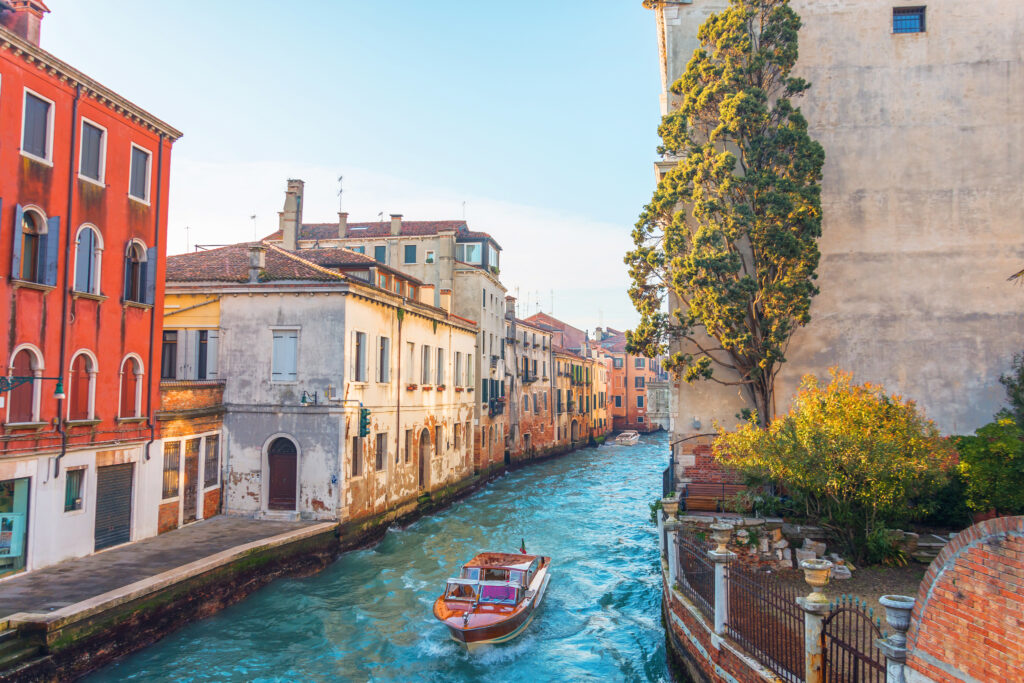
[260,180,508,479]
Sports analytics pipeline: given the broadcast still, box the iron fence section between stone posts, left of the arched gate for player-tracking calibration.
[726,563,805,683]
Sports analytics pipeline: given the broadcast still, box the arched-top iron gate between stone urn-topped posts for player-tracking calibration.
[821,595,886,683]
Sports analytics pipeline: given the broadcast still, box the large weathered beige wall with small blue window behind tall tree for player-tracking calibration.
[645,0,1024,454]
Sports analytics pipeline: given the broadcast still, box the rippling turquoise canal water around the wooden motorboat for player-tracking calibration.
[89,434,669,682]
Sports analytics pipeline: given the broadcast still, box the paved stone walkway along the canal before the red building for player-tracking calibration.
[0,516,327,623]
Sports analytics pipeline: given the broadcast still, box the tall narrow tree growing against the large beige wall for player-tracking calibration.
[626,0,824,424]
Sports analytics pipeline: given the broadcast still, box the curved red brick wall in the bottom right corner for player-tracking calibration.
[906,517,1024,683]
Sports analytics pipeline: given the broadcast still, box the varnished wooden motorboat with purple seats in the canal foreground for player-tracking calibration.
[434,553,551,648]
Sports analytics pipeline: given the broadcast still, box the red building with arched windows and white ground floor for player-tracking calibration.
[0,0,181,575]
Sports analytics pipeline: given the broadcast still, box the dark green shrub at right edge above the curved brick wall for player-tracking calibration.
[956,416,1024,514]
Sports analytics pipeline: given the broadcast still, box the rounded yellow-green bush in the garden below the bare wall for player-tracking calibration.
[714,370,955,561]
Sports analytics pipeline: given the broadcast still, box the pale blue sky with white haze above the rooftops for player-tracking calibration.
[41,0,660,330]
